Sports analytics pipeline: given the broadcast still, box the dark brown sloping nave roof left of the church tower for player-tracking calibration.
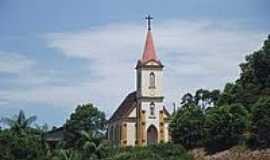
[109,91,137,123]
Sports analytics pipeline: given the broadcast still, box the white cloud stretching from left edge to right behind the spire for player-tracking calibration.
[0,20,266,119]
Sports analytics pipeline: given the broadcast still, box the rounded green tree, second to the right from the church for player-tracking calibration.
[205,104,249,152]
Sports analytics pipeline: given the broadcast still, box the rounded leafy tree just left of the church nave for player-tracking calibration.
[64,104,106,146]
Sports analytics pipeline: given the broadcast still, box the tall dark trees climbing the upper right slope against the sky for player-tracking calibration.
[219,35,270,108]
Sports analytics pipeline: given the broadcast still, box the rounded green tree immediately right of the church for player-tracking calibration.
[170,104,205,148]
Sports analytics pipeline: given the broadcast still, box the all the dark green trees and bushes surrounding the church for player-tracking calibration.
[0,36,270,160]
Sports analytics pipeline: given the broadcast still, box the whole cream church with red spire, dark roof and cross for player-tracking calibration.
[107,16,170,146]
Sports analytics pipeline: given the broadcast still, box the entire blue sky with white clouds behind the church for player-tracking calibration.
[0,0,270,126]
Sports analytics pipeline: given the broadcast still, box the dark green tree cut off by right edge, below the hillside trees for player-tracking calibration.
[248,97,270,148]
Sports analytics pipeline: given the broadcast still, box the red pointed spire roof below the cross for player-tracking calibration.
[142,30,158,63]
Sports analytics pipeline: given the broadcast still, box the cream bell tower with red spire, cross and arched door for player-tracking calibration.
[136,15,164,145]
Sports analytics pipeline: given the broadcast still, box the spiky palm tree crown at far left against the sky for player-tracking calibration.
[2,110,37,134]
